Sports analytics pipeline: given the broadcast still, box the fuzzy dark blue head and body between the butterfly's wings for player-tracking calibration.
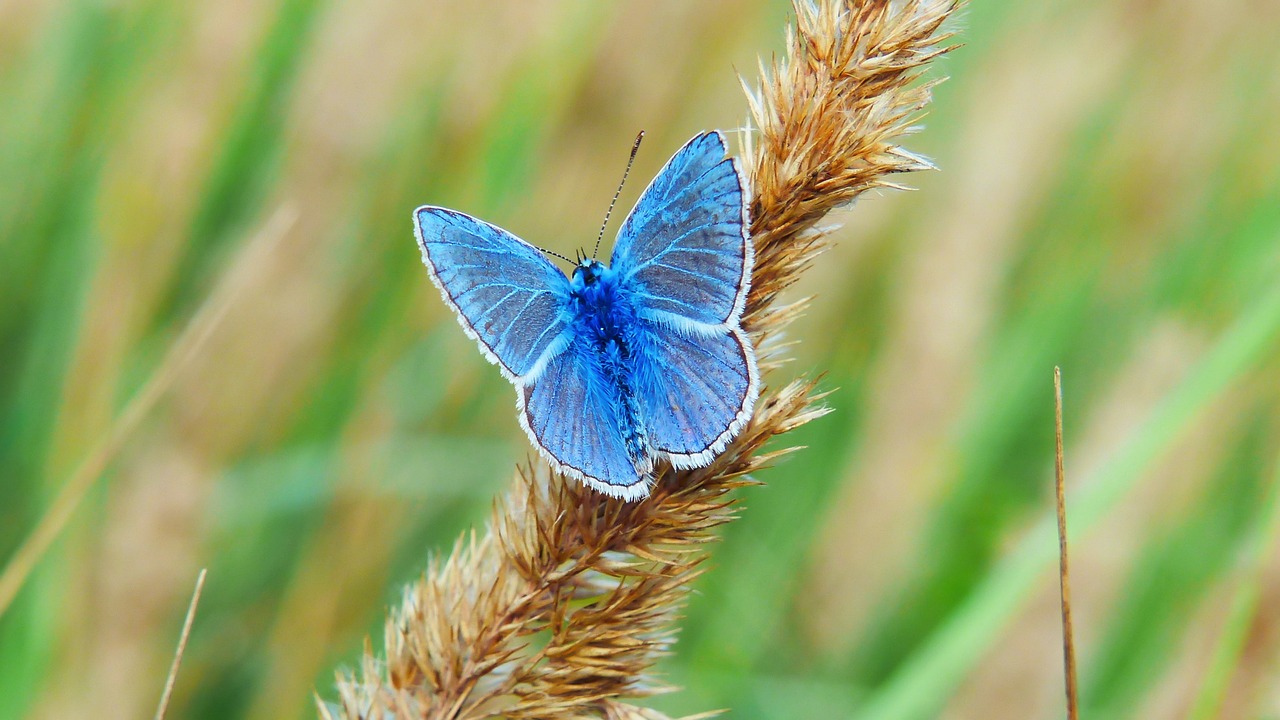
[570,259,648,469]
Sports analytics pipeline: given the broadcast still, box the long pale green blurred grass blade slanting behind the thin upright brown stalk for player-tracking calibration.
[855,279,1280,720]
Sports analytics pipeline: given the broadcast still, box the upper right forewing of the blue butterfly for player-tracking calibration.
[611,132,753,329]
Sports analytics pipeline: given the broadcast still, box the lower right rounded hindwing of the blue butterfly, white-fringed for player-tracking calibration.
[636,324,760,468]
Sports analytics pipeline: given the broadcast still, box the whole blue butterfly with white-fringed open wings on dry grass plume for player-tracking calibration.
[413,132,760,500]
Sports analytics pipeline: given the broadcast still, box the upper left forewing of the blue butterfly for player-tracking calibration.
[413,205,570,386]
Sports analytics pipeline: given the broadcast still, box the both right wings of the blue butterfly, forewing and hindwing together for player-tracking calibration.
[612,132,760,468]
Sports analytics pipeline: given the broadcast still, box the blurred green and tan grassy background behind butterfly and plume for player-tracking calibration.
[0,0,1280,720]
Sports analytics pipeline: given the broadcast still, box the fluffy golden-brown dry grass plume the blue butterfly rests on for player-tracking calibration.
[320,0,956,719]
